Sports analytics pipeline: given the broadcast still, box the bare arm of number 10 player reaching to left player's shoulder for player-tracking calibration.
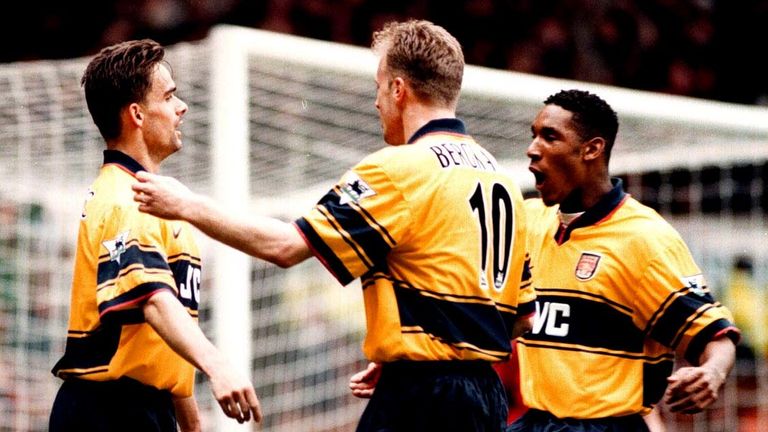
[133,171,312,267]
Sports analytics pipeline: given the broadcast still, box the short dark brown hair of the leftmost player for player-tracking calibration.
[80,39,165,140]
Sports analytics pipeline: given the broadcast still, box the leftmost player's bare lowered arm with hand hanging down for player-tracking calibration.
[143,290,261,423]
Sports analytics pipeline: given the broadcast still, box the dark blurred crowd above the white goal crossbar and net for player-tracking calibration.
[0,0,768,105]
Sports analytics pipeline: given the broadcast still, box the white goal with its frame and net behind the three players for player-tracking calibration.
[0,26,768,431]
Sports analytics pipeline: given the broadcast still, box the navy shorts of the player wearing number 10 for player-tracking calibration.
[357,361,508,432]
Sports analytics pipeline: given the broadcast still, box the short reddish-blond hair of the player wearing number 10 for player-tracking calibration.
[371,20,464,105]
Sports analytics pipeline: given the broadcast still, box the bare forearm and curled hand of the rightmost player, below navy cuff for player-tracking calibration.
[664,336,736,414]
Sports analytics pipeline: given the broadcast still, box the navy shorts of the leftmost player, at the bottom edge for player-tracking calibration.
[48,378,177,432]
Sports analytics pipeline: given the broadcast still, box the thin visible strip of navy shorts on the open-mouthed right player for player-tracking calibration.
[506,409,648,432]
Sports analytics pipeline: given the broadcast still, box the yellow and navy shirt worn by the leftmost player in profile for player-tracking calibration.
[53,150,201,397]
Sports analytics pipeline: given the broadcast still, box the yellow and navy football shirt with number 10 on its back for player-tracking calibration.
[296,119,534,362]
